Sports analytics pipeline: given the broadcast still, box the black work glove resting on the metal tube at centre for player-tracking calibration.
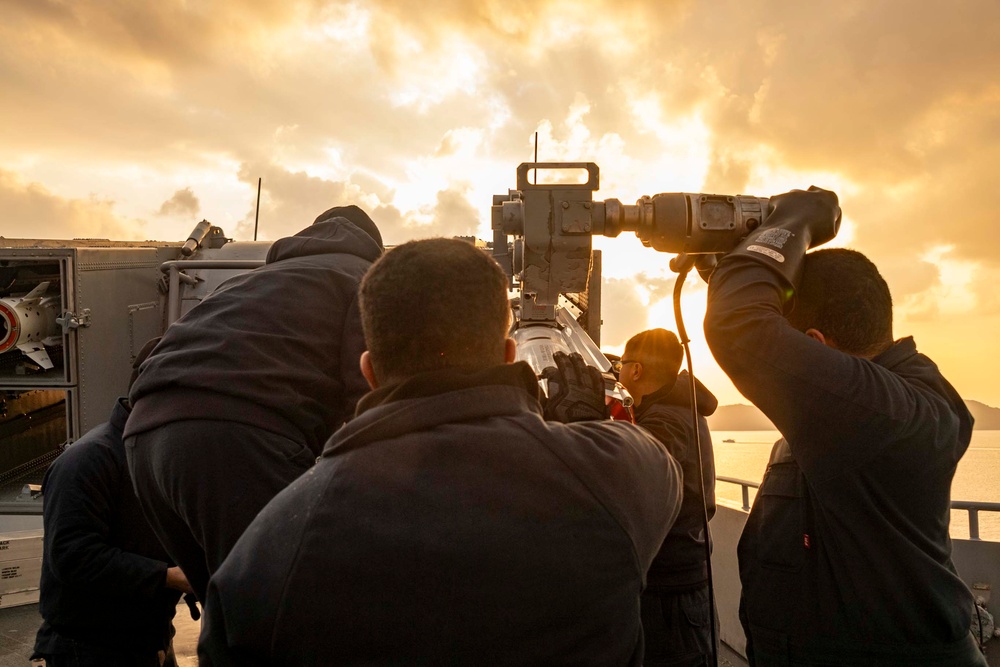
[542,352,608,424]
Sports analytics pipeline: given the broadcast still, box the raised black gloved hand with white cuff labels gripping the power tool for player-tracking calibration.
[727,186,841,289]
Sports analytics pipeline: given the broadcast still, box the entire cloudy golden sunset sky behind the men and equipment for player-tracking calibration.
[0,0,1000,406]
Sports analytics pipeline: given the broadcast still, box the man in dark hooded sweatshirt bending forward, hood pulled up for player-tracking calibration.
[125,206,382,600]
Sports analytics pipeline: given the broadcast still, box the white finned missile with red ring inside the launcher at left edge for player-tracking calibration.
[0,282,62,370]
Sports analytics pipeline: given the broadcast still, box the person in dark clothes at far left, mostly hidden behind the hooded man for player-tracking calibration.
[32,398,190,667]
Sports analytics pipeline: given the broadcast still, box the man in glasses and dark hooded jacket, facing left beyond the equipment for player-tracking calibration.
[619,329,719,667]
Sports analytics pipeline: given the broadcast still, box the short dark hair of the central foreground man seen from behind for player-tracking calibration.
[360,238,510,383]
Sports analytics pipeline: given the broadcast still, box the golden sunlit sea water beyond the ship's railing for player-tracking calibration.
[712,430,1000,542]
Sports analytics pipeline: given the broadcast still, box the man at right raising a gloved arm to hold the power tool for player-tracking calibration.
[705,189,986,667]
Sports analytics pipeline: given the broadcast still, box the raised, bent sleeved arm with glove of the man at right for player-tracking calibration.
[705,190,933,479]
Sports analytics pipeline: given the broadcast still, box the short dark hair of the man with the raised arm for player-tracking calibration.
[788,248,892,357]
